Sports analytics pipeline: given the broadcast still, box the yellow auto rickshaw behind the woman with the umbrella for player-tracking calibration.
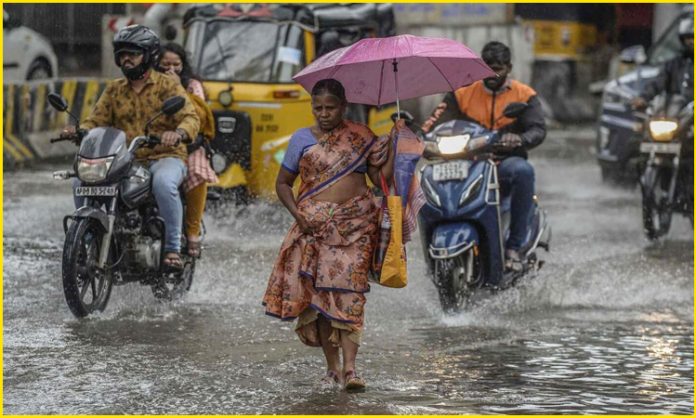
[184,4,394,201]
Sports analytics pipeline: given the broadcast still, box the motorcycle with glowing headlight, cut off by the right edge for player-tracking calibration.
[640,96,694,240]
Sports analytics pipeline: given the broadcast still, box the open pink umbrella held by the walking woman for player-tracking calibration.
[293,35,495,111]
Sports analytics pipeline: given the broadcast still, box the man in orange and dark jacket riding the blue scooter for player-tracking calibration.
[422,41,546,271]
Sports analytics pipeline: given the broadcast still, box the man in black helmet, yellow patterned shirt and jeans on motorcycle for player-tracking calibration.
[61,25,200,268]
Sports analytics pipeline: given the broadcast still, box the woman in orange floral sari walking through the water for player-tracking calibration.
[263,79,394,390]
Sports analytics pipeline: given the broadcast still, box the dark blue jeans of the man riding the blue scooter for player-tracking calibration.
[498,157,534,251]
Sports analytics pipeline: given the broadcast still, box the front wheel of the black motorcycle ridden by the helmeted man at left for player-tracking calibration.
[63,218,113,318]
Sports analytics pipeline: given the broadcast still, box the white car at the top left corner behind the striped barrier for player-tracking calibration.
[2,10,58,82]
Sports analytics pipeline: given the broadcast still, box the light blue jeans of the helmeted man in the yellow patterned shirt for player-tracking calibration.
[73,157,186,253]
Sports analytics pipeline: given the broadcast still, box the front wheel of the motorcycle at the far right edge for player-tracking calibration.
[641,167,672,241]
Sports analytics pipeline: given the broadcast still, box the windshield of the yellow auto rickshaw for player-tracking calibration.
[187,20,304,83]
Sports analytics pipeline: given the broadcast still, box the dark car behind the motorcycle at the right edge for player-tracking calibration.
[597,5,694,186]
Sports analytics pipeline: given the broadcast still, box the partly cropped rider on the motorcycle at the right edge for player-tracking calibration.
[631,16,694,109]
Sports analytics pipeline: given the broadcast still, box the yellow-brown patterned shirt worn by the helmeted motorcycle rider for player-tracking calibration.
[81,70,200,160]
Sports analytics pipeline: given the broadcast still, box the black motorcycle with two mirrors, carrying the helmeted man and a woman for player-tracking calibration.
[48,93,196,317]
